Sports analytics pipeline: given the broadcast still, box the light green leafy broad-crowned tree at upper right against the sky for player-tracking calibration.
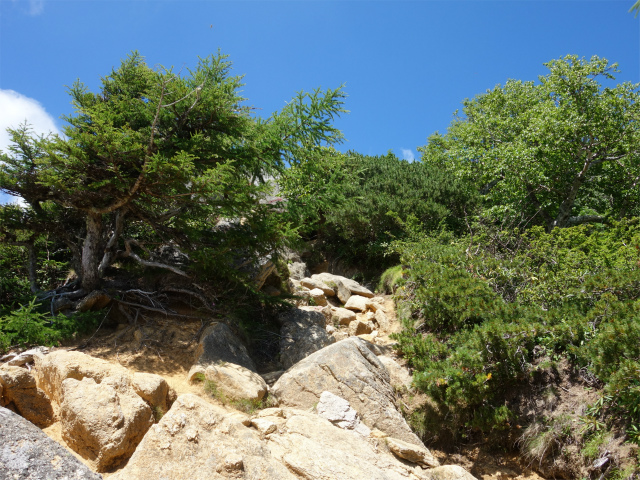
[419,55,640,229]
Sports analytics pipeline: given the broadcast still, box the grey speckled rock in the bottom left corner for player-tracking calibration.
[0,407,102,480]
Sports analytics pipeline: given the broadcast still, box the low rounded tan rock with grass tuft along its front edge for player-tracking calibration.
[204,363,269,400]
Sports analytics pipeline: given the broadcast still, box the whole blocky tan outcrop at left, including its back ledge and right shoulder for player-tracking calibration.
[34,350,173,471]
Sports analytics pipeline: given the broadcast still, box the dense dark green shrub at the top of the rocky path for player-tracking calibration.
[280,152,476,269]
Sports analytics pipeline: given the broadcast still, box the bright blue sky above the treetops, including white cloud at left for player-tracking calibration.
[0,0,640,202]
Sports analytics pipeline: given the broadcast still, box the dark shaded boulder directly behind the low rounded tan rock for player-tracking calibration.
[189,323,256,379]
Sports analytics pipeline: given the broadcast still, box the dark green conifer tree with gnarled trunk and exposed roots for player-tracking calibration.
[0,52,344,291]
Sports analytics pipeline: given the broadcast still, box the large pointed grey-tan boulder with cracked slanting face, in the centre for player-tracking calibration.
[271,337,422,446]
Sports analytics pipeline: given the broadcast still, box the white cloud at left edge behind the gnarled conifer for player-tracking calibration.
[0,89,60,204]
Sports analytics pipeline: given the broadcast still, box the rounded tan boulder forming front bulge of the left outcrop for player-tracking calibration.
[60,377,153,472]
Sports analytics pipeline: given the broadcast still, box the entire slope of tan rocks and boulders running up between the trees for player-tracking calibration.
[0,266,540,480]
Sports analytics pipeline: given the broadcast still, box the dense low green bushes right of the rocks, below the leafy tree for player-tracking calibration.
[395,219,640,440]
